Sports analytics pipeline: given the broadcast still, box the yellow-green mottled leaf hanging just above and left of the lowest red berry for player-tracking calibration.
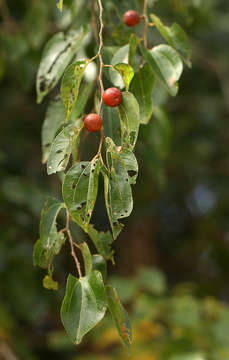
[60,61,87,121]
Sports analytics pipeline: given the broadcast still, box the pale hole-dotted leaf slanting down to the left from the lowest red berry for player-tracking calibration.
[47,120,83,175]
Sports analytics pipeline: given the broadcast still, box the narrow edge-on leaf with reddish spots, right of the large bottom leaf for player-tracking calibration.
[106,285,132,349]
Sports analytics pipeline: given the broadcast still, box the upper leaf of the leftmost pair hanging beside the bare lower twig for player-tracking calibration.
[40,198,64,252]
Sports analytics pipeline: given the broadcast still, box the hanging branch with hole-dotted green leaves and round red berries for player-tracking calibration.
[34,0,190,348]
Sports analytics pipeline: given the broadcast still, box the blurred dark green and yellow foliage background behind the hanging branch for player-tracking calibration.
[0,0,229,360]
